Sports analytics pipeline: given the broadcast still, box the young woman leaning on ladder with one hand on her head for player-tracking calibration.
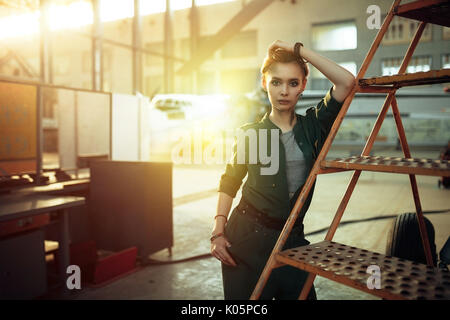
[211,41,355,299]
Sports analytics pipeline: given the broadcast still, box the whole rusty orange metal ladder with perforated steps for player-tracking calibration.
[251,0,450,300]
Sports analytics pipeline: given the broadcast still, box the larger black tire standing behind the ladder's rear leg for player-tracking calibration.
[386,212,437,266]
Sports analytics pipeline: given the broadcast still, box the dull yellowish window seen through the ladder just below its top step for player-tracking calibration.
[382,16,432,45]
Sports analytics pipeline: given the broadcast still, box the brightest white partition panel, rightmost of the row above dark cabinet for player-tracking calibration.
[112,94,140,161]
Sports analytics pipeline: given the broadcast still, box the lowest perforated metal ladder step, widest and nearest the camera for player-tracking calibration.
[276,241,450,300]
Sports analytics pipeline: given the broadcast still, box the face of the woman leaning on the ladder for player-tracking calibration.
[262,61,306,111]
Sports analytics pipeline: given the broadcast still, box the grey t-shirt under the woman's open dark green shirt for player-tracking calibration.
[281,130,306,199]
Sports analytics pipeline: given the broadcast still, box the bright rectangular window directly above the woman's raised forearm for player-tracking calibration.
[311,21,357,51]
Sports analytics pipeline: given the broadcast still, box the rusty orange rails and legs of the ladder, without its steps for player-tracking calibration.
[250,0,440,300]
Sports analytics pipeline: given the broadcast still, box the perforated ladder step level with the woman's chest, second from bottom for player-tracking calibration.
[321,156,450,177]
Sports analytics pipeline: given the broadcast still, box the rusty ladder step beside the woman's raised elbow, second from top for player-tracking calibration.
[359,69,450,87]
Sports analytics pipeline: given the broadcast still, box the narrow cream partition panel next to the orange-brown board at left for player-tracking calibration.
[55,89,77,170]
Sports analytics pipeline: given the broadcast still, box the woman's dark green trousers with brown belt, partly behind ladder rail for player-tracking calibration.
[222,208,316,300]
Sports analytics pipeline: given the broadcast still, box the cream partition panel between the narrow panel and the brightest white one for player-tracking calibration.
[76,91,110,156]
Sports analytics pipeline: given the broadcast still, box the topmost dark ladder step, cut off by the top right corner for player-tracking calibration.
[394,0,450,27]
